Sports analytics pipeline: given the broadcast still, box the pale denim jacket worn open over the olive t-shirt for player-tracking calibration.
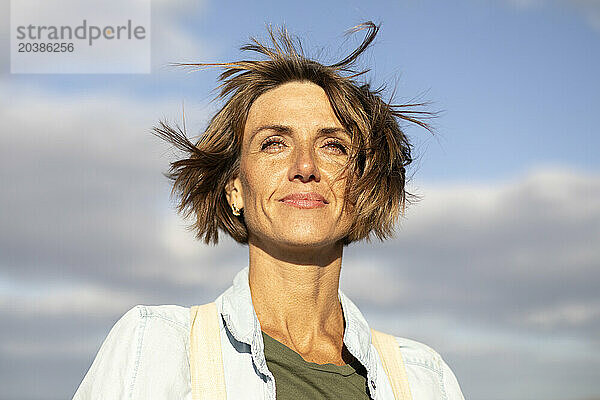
[73,267,464,400]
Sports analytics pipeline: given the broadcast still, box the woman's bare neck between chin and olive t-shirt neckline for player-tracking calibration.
[249,244,352,365]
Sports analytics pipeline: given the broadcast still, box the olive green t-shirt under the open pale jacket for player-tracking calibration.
[262,332,370,400]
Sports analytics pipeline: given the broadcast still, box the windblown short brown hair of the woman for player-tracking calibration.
[153,21,434,245]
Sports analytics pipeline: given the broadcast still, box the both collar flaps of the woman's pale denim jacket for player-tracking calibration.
[215,267,377,398]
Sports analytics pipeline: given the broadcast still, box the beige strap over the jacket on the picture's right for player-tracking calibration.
[371,329,412,400]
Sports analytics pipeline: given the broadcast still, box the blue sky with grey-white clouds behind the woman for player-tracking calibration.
[0,0,600,400]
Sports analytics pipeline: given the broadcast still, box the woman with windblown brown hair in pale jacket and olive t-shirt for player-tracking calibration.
[75,22,463,400]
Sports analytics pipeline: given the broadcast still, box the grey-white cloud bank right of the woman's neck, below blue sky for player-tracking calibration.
[342,167,600,337]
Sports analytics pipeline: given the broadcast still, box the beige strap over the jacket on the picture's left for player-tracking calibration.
[190,302,227,400]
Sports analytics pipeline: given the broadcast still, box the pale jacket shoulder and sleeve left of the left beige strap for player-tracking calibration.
[74,305,190,399]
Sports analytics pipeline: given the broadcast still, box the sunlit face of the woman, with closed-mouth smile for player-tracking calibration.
[229,82,351,247]
